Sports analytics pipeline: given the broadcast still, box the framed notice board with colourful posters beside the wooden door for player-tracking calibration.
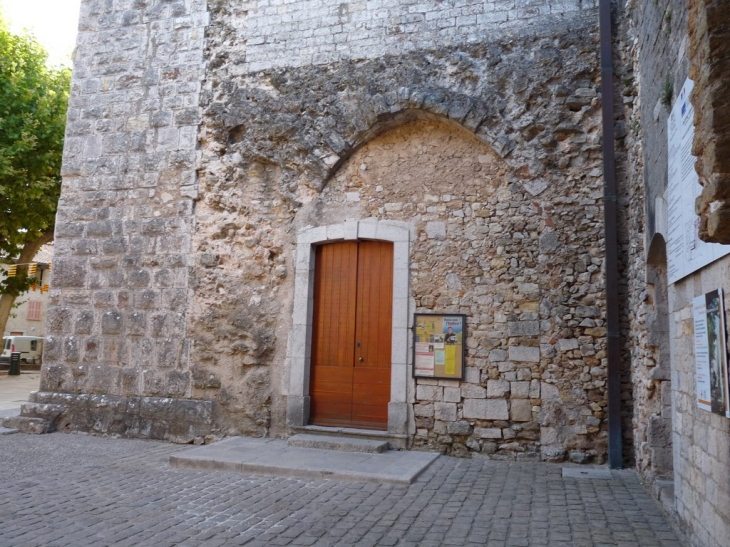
[413,313,466,380]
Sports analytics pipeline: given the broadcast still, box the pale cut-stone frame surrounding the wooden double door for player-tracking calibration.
[287,219,411,436]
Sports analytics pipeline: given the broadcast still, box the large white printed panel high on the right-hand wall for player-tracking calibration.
[667,78,730,284]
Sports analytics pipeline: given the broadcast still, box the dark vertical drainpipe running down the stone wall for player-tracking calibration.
[599,0,623,469]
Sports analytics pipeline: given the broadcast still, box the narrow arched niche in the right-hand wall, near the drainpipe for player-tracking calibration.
[637,233,673,479]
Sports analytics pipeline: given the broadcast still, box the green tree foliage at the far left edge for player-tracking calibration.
[0,19,71,332]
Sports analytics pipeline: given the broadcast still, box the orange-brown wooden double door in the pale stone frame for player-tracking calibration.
[310,241,393,429]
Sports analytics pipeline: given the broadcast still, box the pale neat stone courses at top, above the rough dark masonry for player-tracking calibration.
[236,0,598,73]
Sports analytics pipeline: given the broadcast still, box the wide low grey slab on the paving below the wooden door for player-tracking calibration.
[170,437,439,484]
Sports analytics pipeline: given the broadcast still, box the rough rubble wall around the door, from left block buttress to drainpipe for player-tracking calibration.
[189,2,605,461]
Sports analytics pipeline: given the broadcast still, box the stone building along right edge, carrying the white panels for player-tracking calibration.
[614,0,730,547]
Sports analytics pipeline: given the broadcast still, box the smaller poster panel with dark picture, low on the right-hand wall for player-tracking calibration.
[692,289,730,418]
